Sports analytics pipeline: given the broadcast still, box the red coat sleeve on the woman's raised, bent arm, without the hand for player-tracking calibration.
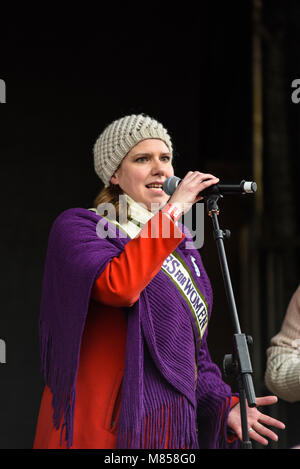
[92,212,184,307]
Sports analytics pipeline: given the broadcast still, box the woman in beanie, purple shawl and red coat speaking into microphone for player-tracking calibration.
[34,114,284,449]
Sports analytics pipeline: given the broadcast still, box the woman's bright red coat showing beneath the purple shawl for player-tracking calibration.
[33,213,239,449]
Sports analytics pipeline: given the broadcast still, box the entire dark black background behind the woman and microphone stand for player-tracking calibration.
[0,0,300,449]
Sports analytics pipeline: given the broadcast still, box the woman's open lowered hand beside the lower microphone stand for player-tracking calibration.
[227,396,285,445]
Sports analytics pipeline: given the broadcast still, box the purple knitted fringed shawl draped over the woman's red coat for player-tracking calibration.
[40,208,237,449]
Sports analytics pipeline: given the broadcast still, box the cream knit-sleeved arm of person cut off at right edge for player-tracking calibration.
[265,286,300,402]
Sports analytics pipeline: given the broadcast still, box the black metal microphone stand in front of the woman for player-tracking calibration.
[205,194,256,449]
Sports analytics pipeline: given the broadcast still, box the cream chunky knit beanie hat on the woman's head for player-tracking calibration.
[94,114,172,187]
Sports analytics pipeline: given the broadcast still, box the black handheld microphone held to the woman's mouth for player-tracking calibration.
[162,176,257,197]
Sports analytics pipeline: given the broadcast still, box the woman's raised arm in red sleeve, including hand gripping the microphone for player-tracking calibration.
[92,171,219,307]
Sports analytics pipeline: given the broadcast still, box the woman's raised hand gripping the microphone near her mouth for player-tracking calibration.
[168,171,219,213]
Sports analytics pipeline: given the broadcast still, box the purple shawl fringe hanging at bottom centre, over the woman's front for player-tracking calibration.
[117,396,199,449]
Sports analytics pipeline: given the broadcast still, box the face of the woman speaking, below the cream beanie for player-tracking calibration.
[111,138,174,210]
